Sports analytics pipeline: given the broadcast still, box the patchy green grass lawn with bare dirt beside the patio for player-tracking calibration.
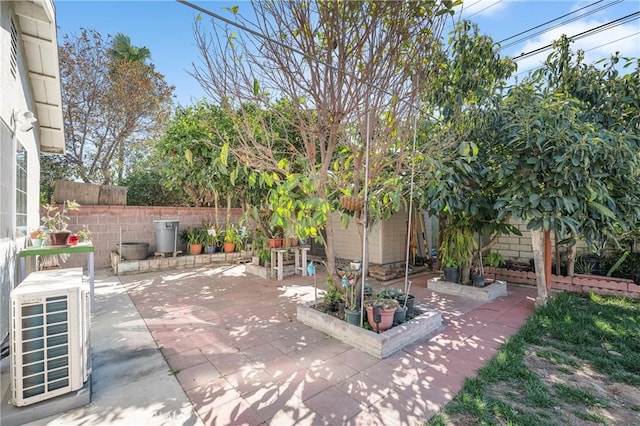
[428,293,640,426]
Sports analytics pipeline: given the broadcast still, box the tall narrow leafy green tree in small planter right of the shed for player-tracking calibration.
[415,21,517,283]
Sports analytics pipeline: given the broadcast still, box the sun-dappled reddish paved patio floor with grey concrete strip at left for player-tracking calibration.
[11,265,535,426]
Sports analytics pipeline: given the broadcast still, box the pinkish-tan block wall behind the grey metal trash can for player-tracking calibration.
[41,205,243,268]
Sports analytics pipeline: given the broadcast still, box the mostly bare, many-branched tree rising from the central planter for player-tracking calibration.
[193,1,451,271]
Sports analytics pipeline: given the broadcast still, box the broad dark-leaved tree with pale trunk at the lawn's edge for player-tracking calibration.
[488,38,640,303]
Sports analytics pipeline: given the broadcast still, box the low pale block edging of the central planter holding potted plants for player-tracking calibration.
[297,304,442,359]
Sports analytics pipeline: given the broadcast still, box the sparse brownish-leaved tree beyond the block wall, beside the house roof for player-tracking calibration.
[59,30,173,184]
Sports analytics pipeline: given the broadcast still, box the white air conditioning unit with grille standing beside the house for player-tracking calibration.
[11,271,91,407]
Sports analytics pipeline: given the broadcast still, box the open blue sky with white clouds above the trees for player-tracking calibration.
[54,0,640,106]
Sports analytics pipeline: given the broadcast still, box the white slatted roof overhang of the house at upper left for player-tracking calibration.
[14,0,65,154]
